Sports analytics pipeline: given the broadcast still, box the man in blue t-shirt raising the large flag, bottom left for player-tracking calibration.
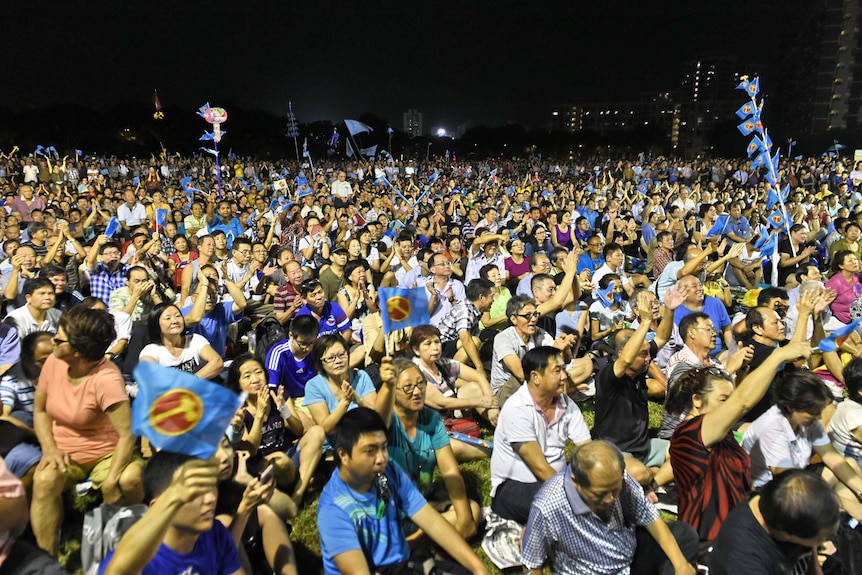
[99,451,250,575]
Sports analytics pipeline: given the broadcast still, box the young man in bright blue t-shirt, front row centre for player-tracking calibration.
[317,407,488,575]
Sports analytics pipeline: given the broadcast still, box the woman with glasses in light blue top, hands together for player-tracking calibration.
[303,335,377,436]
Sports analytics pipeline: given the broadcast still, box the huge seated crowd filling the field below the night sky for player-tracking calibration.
[0,153,862,575]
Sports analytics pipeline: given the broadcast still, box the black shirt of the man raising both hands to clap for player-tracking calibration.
[592,342,657,459]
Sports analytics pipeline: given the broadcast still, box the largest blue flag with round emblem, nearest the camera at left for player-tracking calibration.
[132,361,242,459]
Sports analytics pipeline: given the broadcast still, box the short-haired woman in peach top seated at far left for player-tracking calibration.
[30,306,144,556]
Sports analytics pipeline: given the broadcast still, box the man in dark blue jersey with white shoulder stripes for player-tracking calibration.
[265,315,320,431]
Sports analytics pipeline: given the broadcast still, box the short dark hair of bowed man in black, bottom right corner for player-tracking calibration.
[759,469,840,539]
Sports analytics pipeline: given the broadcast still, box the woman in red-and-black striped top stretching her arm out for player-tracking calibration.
[665,342,811,541]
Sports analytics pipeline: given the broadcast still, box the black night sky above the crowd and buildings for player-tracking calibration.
[0,0,807,131]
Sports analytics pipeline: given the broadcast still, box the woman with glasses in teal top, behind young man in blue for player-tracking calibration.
[378,358,482,541]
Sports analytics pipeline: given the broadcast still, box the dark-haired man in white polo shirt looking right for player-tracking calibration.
[491,346,590,523]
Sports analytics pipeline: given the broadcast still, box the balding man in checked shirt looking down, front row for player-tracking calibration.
[521,441,698,575]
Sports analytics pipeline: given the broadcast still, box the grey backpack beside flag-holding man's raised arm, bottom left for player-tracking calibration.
[81,503,147,575]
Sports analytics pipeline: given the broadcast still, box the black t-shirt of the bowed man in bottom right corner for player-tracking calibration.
[709,501,811,575]
